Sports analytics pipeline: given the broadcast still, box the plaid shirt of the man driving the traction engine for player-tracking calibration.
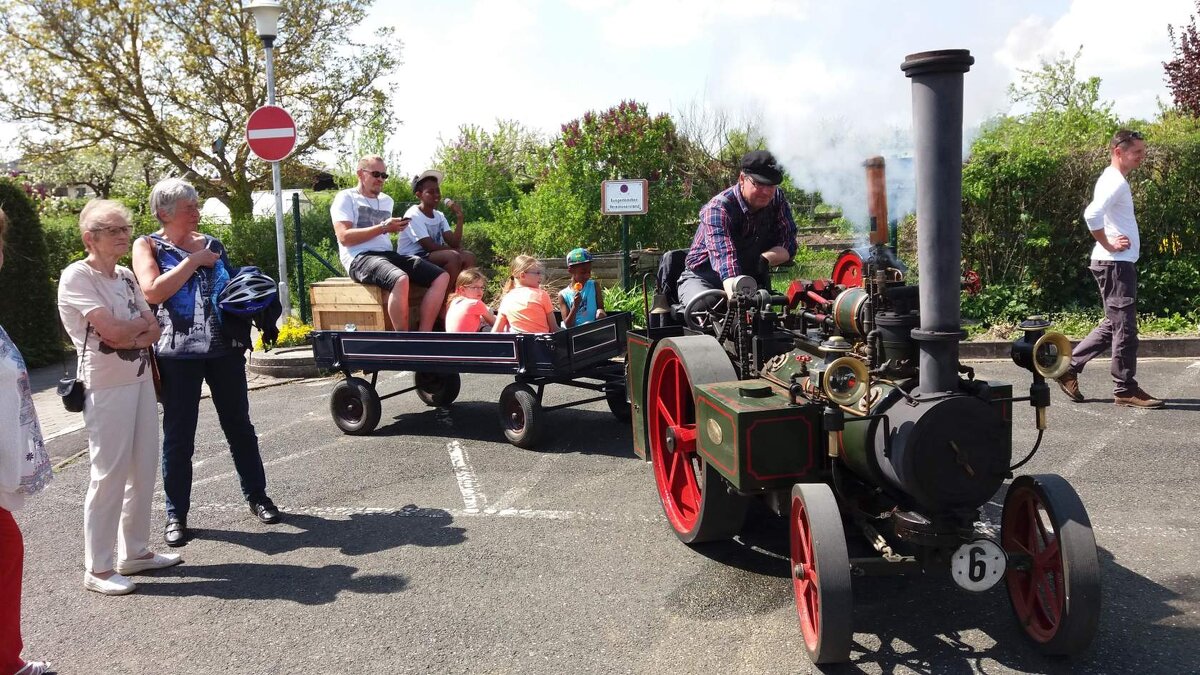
[684,185,796,280]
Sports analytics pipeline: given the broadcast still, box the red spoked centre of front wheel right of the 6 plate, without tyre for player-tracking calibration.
[1003,488,1066,643]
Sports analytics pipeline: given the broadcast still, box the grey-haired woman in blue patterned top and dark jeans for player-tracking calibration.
[133,178,280,546]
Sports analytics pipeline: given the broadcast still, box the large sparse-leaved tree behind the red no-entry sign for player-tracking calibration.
[0,0,400,219]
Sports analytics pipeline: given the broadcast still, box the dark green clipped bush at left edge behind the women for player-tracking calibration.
[0,180,63,368]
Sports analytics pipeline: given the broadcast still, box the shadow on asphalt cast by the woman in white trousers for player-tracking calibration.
[129,562,408,605]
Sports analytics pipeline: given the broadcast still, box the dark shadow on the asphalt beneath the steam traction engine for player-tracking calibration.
[667,506,1200,674]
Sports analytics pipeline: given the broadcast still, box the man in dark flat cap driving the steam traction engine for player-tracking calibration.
[678,150,796,305]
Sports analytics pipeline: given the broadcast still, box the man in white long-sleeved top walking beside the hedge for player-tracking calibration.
[1058,129,1163,408]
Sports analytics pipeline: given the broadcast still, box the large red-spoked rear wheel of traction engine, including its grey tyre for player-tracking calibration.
[646,335,746,544]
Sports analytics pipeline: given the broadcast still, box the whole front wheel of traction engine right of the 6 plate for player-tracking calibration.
[1001,473,1100,656]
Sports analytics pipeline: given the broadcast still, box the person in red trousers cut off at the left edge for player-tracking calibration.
[0,211,52,675]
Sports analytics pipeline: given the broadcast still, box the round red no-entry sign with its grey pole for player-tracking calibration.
[246,103,292,321]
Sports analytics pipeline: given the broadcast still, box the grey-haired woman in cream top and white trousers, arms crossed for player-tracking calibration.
[59,199,180,596]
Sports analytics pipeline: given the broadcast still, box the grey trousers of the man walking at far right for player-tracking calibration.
[1070,261,1138,396]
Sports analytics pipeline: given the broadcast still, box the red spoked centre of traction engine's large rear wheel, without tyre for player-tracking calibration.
[647,347,702,532]
